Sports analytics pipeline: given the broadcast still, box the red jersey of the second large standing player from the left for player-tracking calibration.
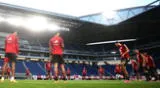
[49,36,64,55]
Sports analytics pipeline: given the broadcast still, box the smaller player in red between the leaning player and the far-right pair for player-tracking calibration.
[131,60,140,80]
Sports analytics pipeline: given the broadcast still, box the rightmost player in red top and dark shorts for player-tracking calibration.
[144,52,158,81]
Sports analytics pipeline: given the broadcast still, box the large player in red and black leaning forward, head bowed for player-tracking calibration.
[115,43,130,83]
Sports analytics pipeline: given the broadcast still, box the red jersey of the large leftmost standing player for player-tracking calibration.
[5,34,19,54]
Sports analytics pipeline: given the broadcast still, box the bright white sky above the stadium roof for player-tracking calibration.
[0,0,155,17]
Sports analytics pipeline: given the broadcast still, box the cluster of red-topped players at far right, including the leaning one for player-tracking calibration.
[115,43,159,83]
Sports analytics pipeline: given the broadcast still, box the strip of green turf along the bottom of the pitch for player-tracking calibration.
[0,80,160,88]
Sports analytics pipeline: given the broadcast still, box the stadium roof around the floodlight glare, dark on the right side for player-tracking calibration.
[0,3,160,44]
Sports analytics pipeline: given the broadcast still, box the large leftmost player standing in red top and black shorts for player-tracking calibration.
[1,32,19,82]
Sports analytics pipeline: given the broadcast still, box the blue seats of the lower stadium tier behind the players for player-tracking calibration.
[0,60,136,76]
